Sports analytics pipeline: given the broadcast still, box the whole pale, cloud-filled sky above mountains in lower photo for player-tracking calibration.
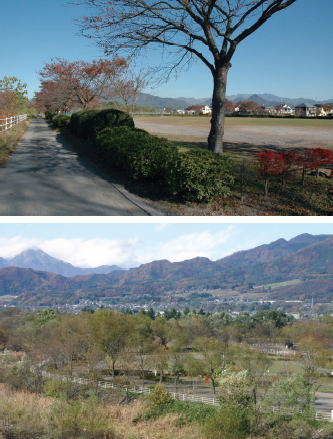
[0,223,333,267]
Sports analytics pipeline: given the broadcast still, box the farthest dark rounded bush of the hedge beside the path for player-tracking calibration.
[70,109,134,140]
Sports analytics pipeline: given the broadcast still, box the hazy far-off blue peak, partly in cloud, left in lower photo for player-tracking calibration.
[0,249,122,277]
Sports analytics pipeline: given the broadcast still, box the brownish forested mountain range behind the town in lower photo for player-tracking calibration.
[0,234,333,305]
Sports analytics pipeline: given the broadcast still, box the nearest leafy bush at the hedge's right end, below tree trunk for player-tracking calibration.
[175,150,233,201]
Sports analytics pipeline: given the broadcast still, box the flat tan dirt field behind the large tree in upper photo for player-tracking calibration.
[135,116,333,149]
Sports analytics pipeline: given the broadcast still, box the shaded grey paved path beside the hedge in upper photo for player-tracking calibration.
[0,119,161,216]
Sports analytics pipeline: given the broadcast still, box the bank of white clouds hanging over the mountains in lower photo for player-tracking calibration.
[0,226,234,267]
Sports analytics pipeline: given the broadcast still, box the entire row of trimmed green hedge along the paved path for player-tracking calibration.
[64,109,233,202]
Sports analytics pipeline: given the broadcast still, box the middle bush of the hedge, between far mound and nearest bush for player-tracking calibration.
[96,127,179,194]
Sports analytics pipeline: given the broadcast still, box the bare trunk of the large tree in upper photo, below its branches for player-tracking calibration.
[208,64,231,154]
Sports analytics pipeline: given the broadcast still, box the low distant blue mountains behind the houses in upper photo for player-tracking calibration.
[137,93,333,109]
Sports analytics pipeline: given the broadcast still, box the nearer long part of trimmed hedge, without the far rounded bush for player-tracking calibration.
[96,127,233,202]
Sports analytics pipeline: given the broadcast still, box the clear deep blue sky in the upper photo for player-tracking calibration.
[0,0,333,100]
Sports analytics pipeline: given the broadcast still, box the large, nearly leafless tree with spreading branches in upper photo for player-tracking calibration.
[81,0,297,153]
